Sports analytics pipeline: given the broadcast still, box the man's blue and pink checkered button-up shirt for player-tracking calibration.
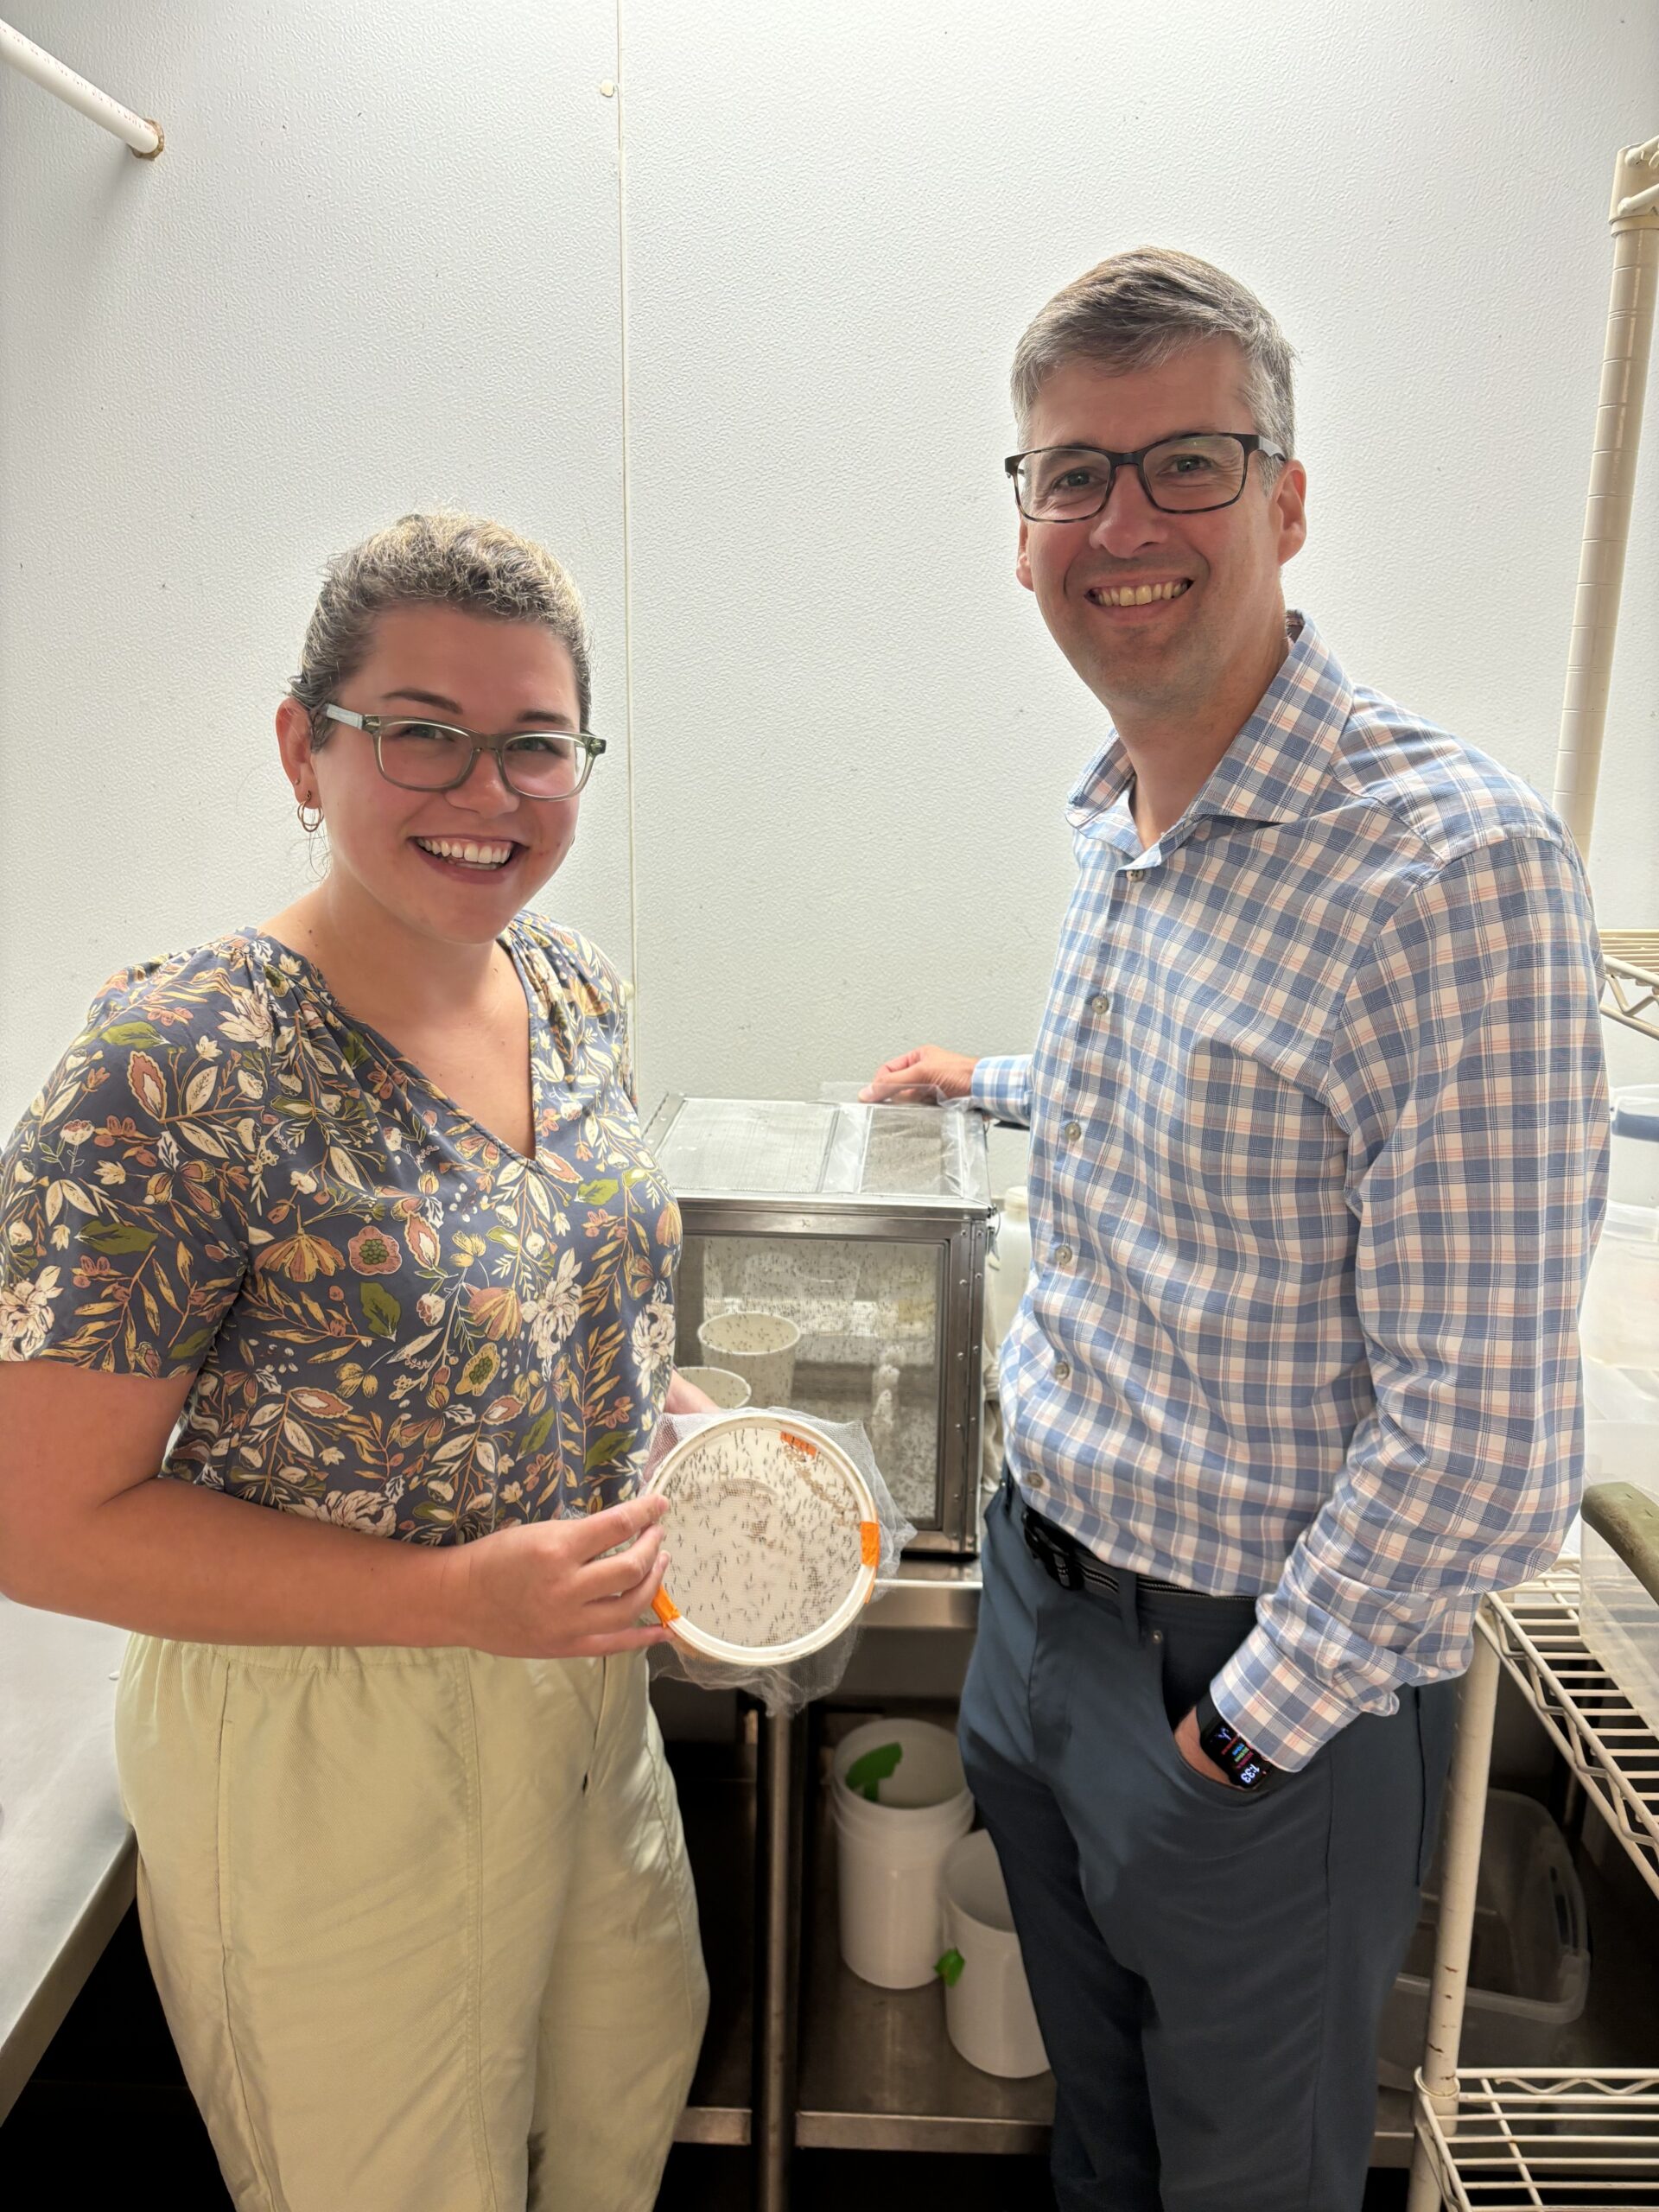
[973,615,1608,1770]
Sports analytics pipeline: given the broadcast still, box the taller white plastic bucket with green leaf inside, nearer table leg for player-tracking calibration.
[830,1721,973,1988]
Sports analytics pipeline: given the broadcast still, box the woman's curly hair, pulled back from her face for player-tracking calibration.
[288,511,593,746]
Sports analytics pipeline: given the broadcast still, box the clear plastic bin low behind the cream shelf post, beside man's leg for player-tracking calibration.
[1378,1787,1591,2088]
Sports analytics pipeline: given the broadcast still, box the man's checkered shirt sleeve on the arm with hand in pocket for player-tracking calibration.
[1211,834,1608,1770]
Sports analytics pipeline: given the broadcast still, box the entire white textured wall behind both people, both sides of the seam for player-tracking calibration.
[0,0,1659,1126]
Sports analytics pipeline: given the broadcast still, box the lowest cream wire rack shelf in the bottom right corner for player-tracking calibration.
[1418,2069,1659,2212]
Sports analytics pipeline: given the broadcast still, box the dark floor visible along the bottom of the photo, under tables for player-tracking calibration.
[0,1913,1405,2212]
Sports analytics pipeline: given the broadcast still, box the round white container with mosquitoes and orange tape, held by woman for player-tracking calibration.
[651,1414,880,1668]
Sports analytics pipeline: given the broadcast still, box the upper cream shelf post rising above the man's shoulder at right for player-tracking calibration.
[1555,139,1659,852]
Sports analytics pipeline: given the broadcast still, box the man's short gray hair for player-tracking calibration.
[1011,245,1296,454]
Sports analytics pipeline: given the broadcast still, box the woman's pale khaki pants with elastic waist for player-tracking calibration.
[115,1637,708,2212]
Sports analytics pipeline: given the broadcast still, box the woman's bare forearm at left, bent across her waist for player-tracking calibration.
[7,1478,471,1646]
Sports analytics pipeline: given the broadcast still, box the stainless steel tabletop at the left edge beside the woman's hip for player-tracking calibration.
[0,1597,135,2119]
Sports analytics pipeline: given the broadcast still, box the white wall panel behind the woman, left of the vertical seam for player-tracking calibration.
[0,0,628,1106]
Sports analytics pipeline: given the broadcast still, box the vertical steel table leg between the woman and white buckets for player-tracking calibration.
[752,1712,807,2212]
